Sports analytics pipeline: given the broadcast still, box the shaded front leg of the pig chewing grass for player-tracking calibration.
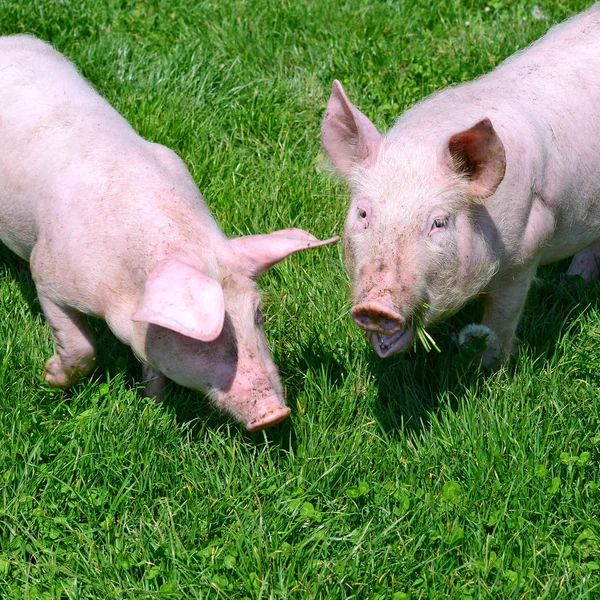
[481,269,535,367]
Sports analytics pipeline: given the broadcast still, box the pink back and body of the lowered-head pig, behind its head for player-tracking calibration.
[0,36,224,316]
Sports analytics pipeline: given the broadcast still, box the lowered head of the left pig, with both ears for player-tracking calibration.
[126,229,337,431]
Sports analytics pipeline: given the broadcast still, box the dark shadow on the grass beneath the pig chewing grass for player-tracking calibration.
[370,259,600,436]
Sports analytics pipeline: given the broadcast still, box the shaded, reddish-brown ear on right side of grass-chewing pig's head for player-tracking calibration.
[448,119,506,198]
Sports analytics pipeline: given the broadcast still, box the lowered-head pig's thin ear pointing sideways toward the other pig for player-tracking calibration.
[228,229,340,277]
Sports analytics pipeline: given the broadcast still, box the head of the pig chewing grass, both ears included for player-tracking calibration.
[322,81,506,357]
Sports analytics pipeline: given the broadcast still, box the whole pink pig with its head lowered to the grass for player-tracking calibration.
[0,35,335,430]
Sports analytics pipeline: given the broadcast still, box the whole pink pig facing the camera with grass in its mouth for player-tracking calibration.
[322,5,600,365]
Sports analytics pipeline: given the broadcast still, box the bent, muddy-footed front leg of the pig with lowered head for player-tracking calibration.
[39,294,96,388]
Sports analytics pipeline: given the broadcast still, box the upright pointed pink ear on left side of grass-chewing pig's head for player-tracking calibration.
[321,79,382,175]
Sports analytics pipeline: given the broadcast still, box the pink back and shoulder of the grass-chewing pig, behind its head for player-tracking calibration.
[388,5,600,262]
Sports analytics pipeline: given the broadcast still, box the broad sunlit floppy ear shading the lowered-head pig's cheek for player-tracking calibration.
[131,259,225,342]
